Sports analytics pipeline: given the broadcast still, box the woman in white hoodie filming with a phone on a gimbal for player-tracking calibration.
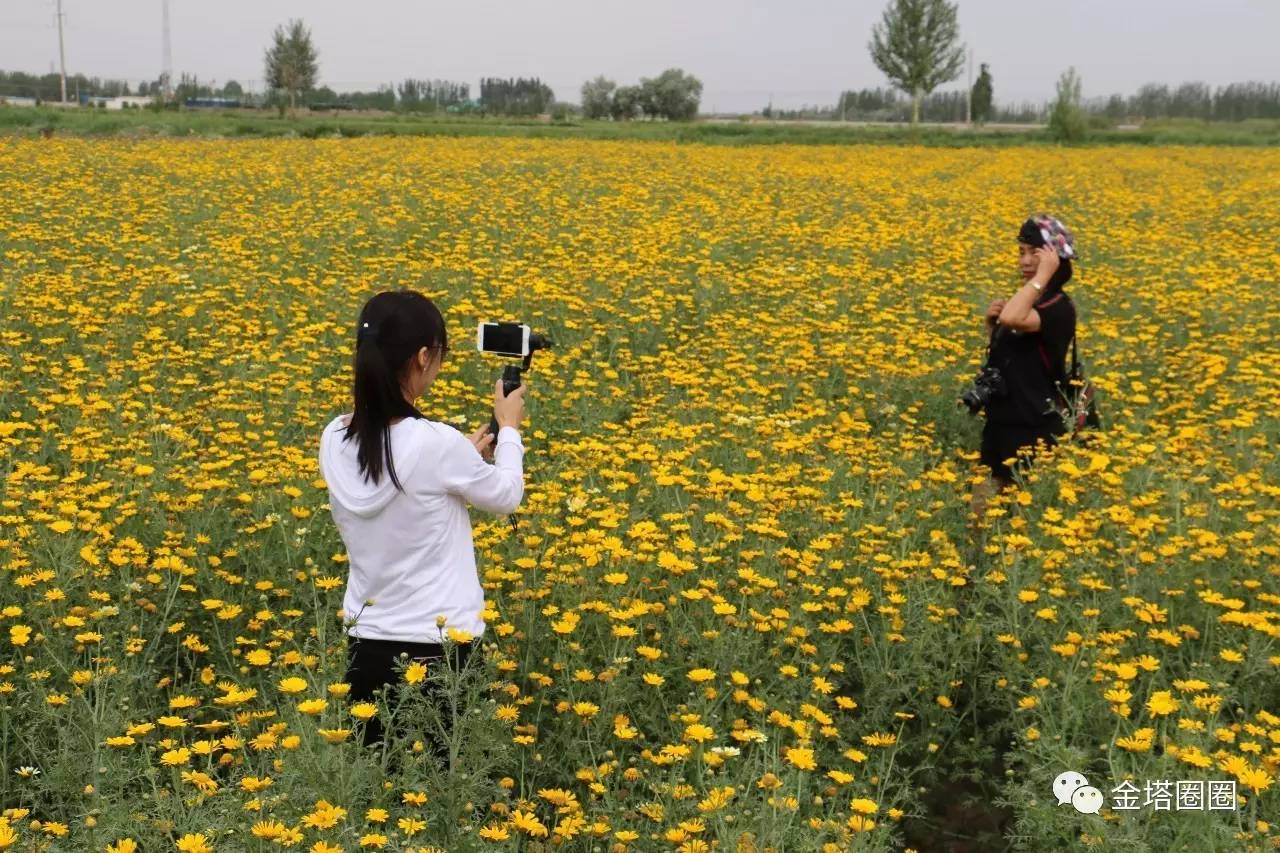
[320,291,525,758]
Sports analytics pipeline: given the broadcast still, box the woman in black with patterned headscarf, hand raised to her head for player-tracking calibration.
[973,214,1075,517]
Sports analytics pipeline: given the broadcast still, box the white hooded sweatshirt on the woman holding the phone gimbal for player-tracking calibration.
[320,415,525,643]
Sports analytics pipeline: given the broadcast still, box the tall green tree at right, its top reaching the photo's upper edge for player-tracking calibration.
[868,0,964,124]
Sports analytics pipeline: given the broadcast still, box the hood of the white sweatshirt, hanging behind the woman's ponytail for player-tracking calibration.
[320,415,428,517]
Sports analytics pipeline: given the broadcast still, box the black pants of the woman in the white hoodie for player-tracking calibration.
[347,634,480,766]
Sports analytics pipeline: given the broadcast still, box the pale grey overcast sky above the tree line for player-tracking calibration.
[0,0,1280,111]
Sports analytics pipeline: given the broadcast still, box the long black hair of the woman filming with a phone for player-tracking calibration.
[343,291,449,492]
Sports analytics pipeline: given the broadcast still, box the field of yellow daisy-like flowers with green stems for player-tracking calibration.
[0,137,1280,853]
